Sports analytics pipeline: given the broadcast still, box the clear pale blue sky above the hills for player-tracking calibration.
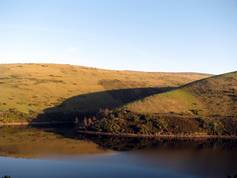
[0,0,237,74]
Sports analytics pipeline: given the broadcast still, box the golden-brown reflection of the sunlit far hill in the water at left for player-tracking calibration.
[0,127,109,158]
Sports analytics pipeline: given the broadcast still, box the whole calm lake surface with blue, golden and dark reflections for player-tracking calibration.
[0,128,237,178]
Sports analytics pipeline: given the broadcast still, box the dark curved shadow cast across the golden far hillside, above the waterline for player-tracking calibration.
[32,87,175,123]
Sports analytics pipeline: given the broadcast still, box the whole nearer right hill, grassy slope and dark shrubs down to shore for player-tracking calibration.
[86,72,237,135]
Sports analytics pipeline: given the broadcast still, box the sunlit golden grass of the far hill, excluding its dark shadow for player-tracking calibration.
[0,64,209,120]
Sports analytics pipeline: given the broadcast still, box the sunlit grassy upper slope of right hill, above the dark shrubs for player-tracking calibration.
[126,72,237,116]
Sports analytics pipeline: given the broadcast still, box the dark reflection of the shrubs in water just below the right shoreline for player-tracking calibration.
[79,135,237,151]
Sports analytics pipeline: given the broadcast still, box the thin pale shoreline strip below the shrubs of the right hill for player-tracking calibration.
[77,130,237,140]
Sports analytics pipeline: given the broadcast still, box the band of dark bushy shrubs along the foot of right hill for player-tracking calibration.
[84,109,237,135]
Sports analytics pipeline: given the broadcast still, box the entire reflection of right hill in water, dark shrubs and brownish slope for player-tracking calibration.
[78,135,237,178]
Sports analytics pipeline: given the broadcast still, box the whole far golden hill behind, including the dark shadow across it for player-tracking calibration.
[0,64,209,122]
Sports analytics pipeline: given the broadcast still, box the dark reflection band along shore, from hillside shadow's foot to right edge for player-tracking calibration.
[36,126,237,151]
